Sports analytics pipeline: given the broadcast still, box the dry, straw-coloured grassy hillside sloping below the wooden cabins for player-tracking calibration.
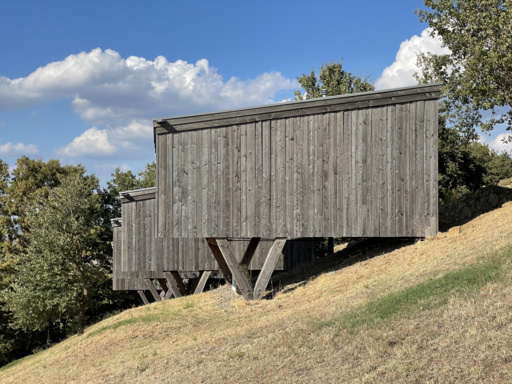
[0,203,512,383]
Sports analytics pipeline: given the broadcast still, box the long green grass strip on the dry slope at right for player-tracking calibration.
[312,247,512,332]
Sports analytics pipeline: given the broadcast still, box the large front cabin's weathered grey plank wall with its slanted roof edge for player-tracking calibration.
[155,85,440,238]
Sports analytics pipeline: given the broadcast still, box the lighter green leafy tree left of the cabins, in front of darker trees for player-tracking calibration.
[2,174,110,334]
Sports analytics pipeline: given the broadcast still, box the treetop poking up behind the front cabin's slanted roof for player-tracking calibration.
[294,59,375,100]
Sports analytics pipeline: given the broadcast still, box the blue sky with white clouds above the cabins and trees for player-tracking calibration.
[0,0,502,183]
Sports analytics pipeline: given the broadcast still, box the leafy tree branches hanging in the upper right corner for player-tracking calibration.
[416,0,512,140]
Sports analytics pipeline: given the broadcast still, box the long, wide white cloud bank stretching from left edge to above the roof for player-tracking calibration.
[0,48,297,126]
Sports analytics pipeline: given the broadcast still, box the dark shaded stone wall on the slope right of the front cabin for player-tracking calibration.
[439,178,512,231]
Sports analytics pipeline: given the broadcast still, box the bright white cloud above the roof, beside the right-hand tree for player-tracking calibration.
[375,28,450,89]
